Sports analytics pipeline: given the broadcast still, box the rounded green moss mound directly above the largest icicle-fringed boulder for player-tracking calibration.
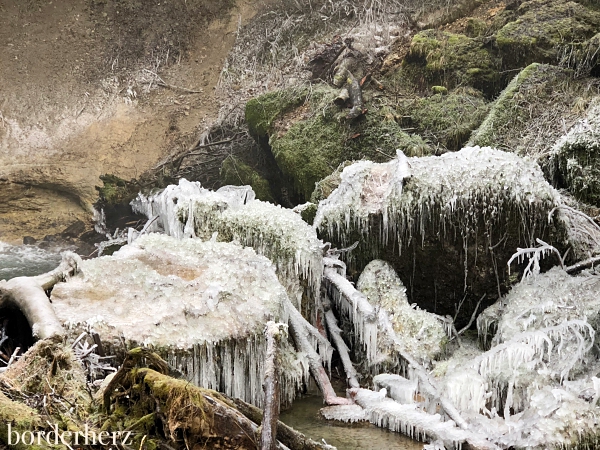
[401,88,489,151]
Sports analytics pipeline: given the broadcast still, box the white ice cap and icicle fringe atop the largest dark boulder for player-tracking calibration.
[314,147,561,255]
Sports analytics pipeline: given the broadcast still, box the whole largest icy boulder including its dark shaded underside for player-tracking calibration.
[314,147,565,326]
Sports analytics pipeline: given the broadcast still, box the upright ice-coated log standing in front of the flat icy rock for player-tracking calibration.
[260,321,287,450]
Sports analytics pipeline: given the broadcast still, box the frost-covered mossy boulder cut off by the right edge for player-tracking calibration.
[550,97,600,206]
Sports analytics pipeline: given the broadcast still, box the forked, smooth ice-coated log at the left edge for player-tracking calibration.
[0,252,81,339]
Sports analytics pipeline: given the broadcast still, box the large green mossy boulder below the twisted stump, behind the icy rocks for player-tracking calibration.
[246,85,432,201]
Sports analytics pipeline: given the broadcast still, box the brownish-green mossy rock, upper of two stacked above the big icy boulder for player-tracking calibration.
[403,30,501,95]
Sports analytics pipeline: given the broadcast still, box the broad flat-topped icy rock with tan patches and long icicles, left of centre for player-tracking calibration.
[52,234,307,405]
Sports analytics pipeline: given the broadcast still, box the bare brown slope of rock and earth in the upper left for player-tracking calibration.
[0,0,247,243]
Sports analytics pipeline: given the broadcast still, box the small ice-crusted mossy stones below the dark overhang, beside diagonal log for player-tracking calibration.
[356,260,446,367]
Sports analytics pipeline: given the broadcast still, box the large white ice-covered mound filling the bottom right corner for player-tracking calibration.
[426,268,600,448]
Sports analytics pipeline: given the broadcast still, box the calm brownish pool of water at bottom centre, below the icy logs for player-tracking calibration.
[279,392,423,450]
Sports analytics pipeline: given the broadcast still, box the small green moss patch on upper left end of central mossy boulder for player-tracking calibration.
[245,88,308,137]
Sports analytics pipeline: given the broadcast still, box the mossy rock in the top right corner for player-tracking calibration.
[496,0,600,67]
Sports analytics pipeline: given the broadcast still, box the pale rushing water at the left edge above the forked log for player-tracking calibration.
[0,242,61,280]
